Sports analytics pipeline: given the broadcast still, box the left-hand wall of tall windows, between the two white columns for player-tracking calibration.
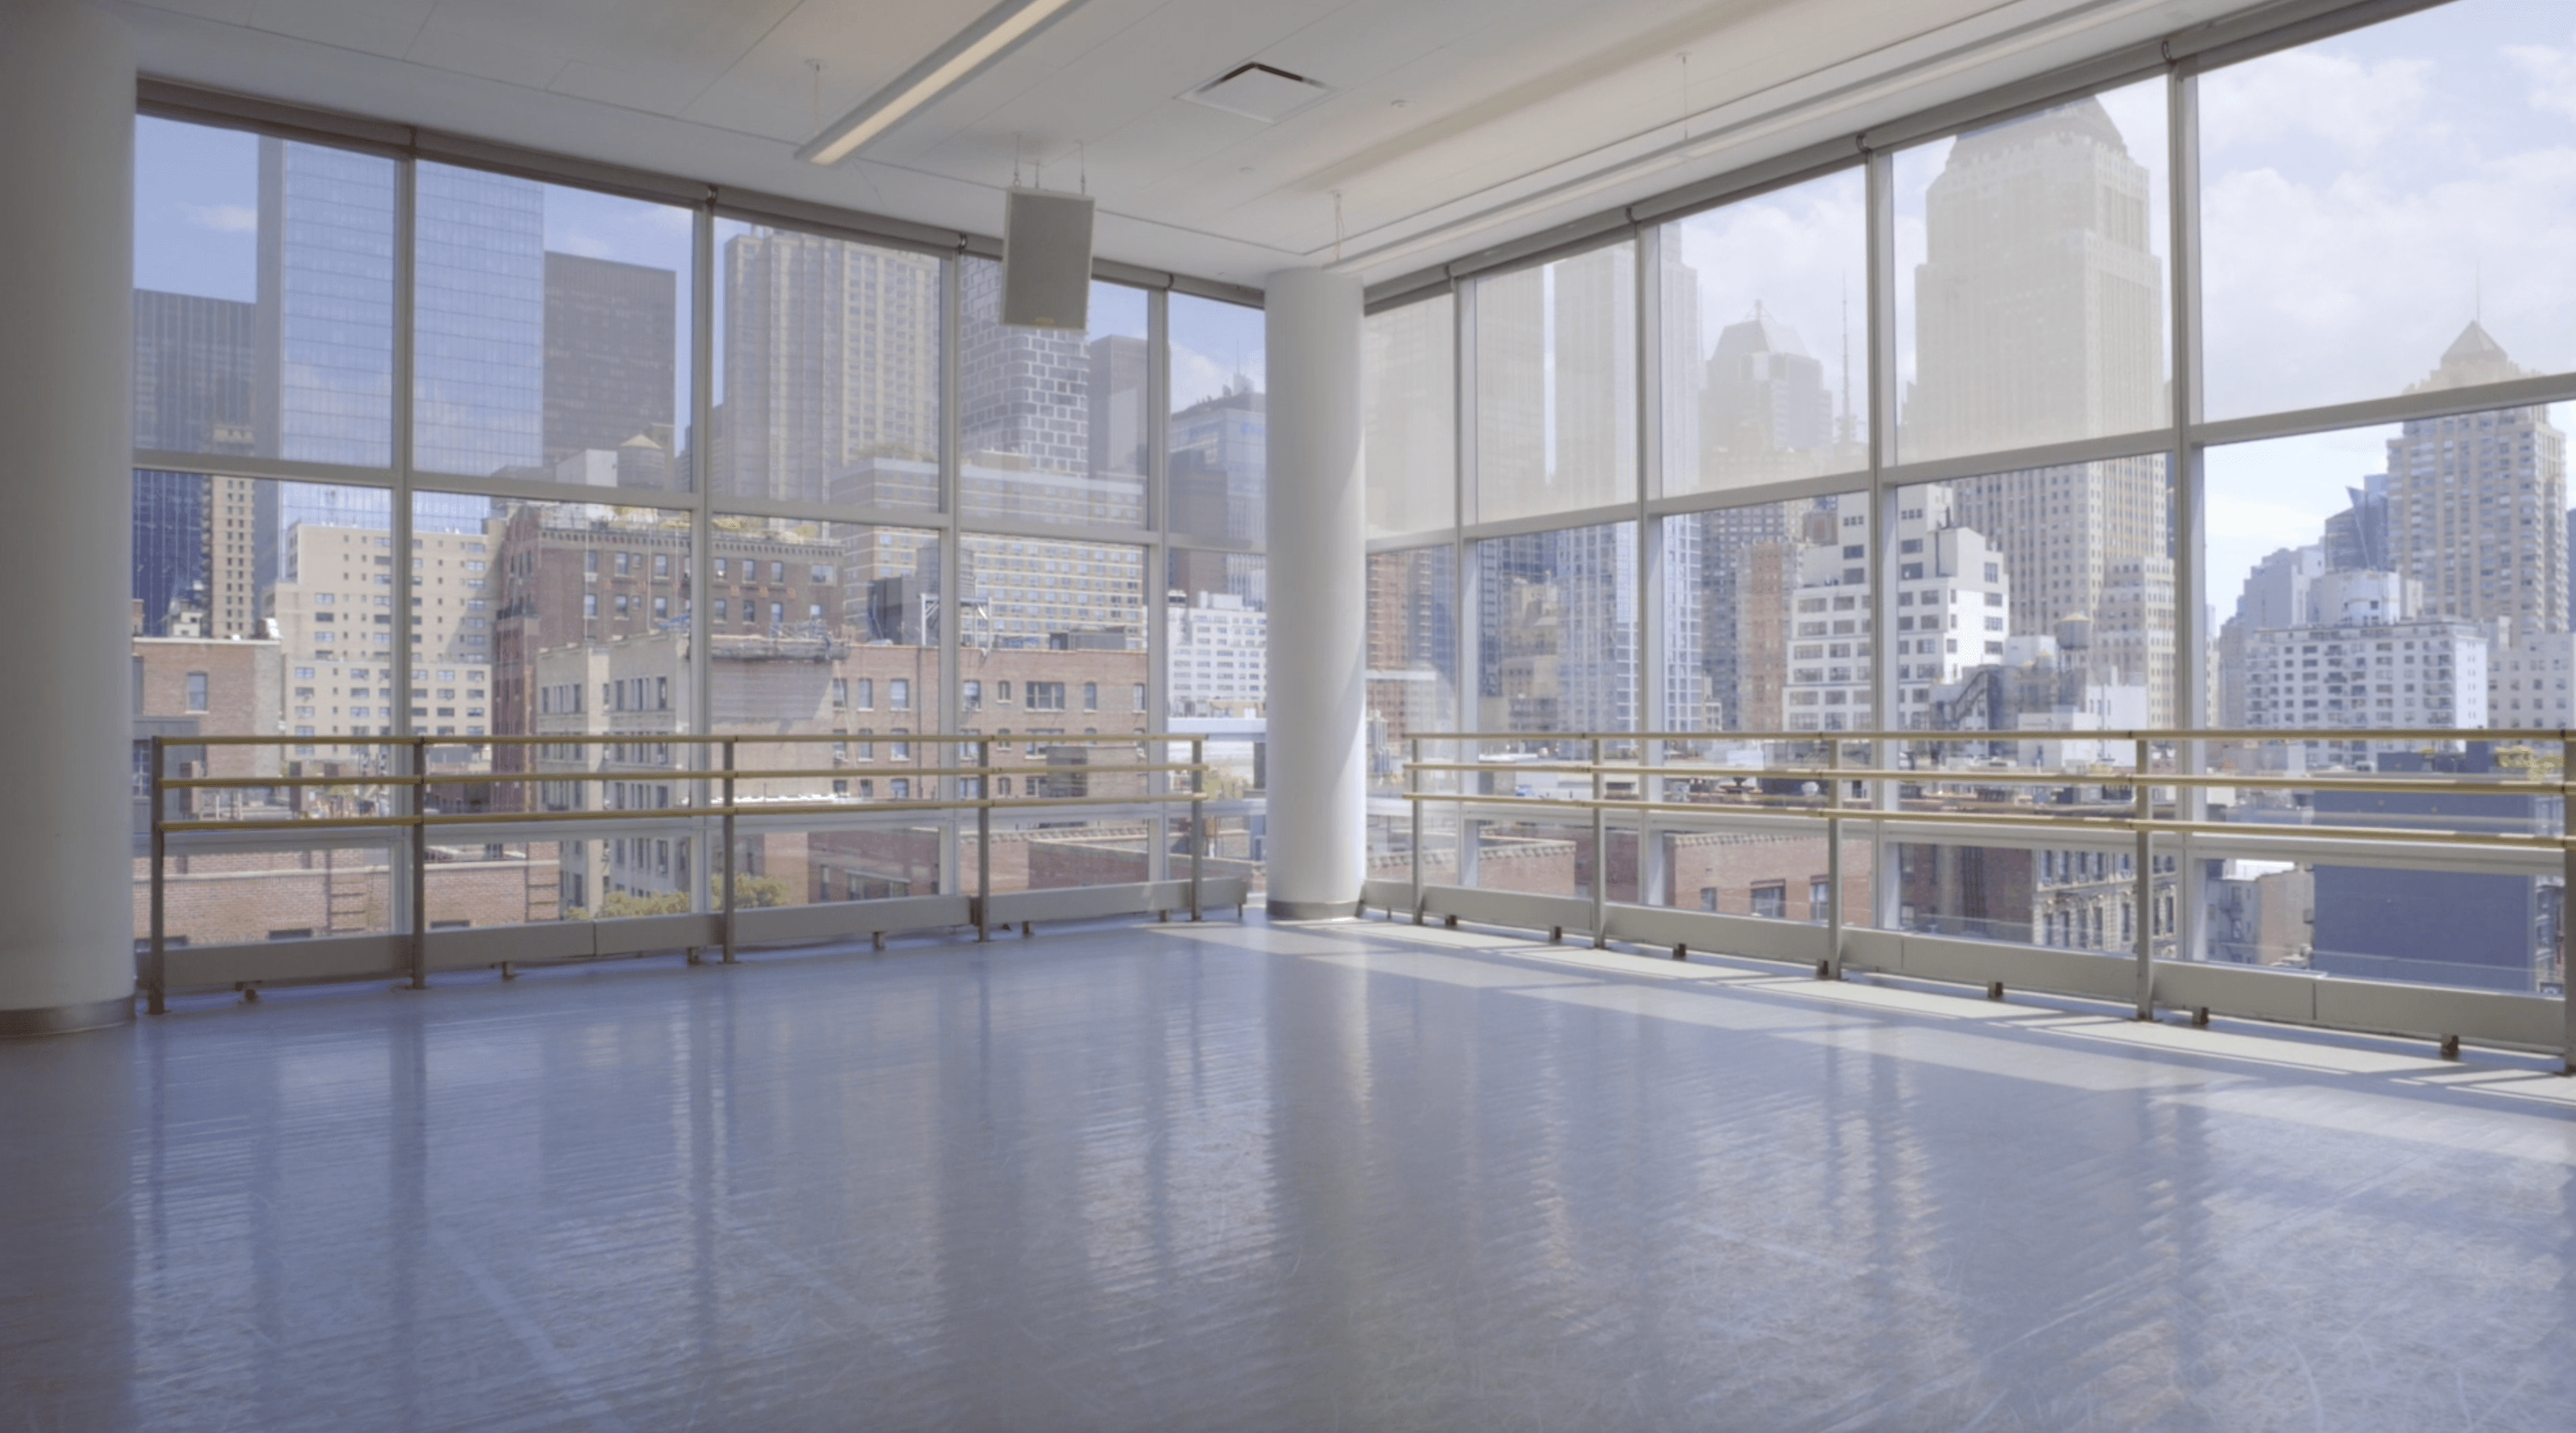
[131,116,1268,943]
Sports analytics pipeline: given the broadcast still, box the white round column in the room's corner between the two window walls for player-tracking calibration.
[1268,268,1368,920]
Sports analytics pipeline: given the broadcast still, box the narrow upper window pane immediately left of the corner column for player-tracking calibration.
[1170,294,1270,546]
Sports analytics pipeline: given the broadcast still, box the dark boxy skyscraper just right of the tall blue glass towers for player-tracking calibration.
[543,253,680,461]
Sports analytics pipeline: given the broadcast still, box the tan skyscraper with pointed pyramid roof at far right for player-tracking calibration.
[2388,322,2568,637]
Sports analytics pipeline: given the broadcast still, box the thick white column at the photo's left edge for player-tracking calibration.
[0,0,134,1033]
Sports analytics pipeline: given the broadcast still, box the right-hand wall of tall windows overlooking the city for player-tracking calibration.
[1363,0,2576,993]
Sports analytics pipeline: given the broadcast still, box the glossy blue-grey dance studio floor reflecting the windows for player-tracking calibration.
[0,923,2576,1430]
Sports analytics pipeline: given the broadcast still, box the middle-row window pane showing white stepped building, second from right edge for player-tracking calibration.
[1888,453,2182,732]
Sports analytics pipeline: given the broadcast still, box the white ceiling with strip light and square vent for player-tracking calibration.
[100,0,2256,283]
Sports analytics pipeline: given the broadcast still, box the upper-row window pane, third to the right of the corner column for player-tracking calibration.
[1661,168,1870,492]
